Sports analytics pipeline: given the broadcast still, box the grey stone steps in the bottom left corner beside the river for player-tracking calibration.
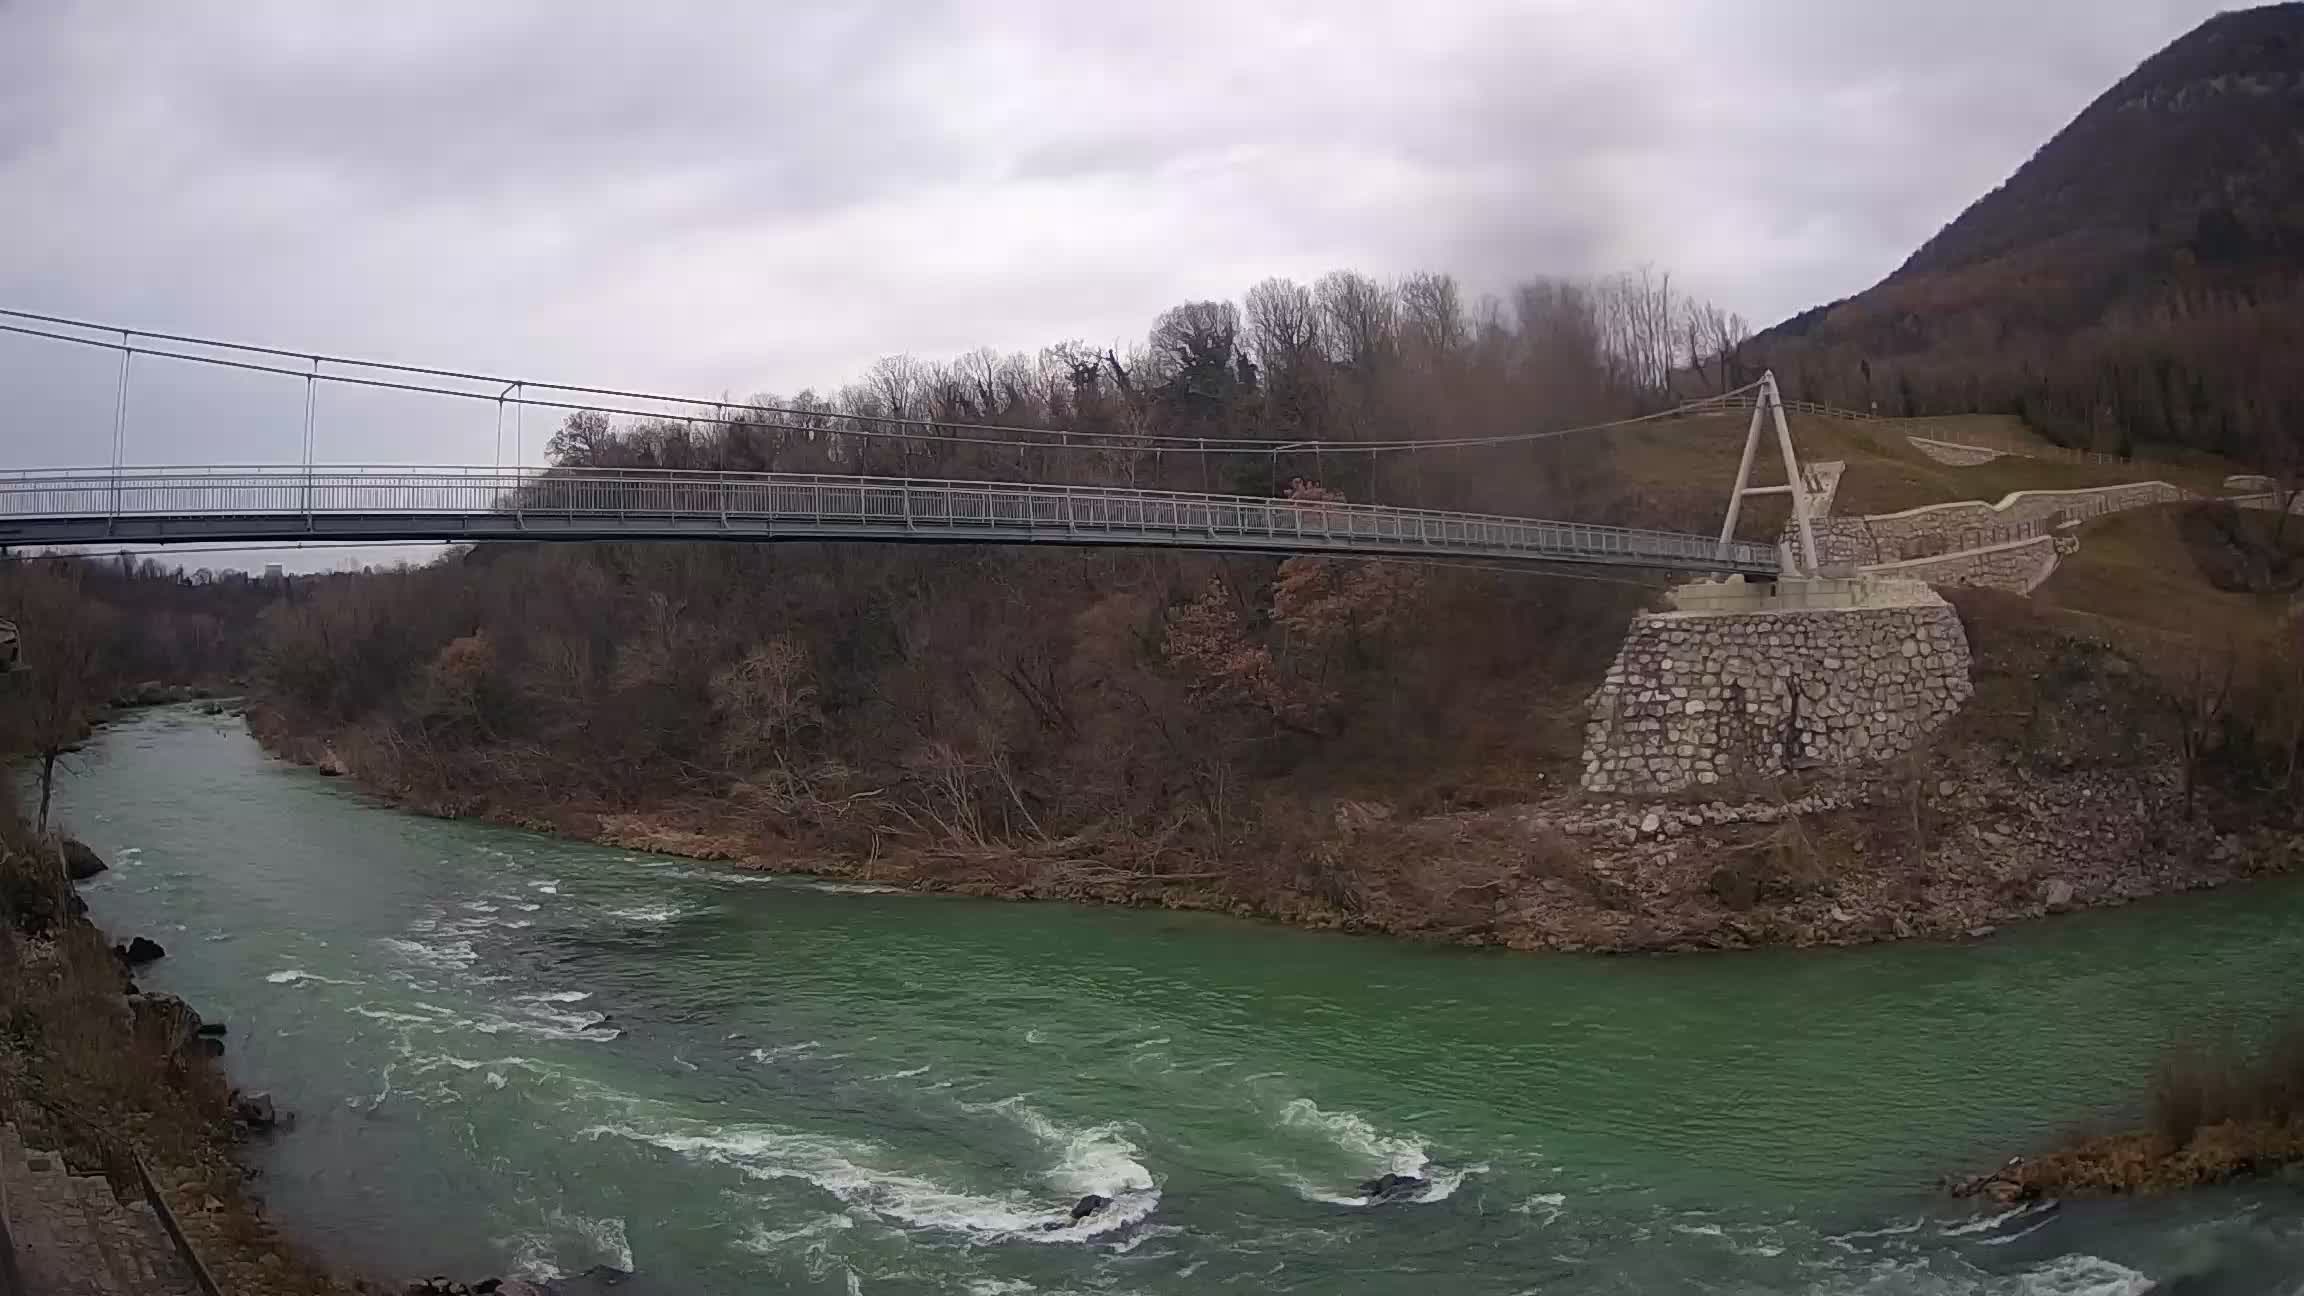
[0,1125,200,1296]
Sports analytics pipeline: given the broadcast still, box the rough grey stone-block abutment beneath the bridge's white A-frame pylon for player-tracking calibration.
[1583,583,1975,796]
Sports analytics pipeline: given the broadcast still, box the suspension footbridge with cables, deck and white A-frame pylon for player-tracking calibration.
[0,309,1813,577]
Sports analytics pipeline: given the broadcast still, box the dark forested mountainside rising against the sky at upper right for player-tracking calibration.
[1751,5,2304,475]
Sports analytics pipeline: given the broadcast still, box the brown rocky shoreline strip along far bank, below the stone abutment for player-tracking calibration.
[249,706,2304,955]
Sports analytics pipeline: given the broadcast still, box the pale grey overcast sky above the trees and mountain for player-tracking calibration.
[0,0,2219,562]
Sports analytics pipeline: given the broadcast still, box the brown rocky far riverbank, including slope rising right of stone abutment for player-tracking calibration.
[233,581,2304,952]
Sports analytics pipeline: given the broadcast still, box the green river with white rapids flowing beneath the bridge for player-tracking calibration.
[40,708,2304,1296]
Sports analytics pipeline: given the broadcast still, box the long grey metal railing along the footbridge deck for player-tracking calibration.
[0,466,1776,572]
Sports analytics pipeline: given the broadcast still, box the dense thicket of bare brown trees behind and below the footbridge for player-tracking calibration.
[258,262,1740,858]
